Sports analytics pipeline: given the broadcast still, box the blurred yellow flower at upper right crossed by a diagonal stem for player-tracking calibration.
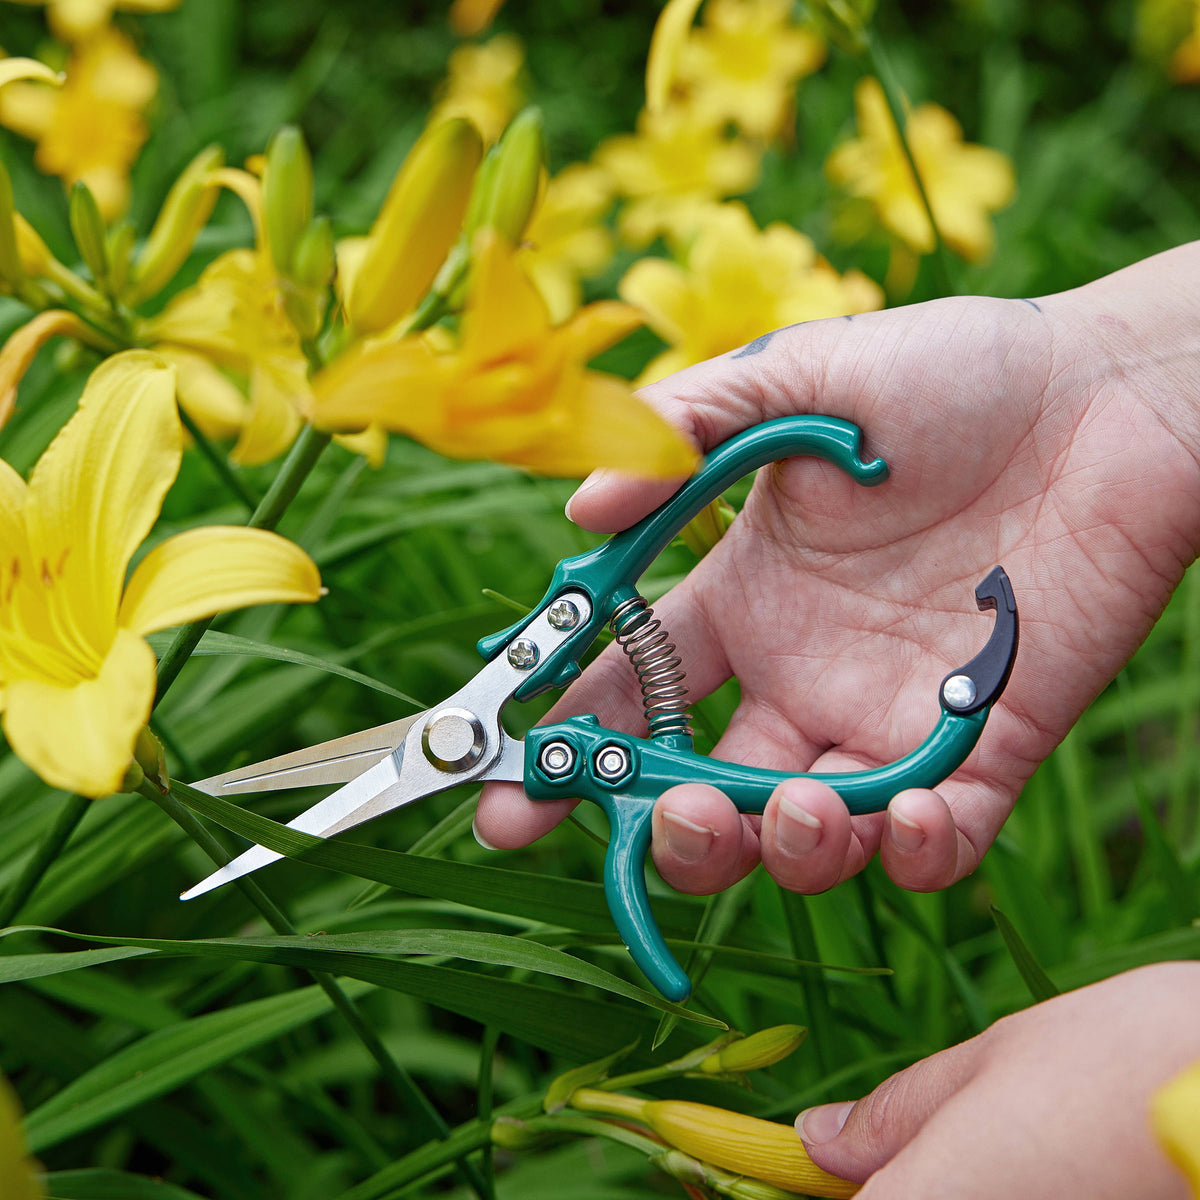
[826,77,1016,262]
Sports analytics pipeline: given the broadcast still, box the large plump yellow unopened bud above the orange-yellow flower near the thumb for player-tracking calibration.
[348,118,484,334]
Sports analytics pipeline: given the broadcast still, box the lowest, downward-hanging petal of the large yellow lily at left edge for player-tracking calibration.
[4,629,155,797]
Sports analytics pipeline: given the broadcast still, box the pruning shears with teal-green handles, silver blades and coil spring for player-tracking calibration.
[181,416,1019,1001]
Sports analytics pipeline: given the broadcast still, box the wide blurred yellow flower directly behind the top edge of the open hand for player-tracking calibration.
[619,204,883,384]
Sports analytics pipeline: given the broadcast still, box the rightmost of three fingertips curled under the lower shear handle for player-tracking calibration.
[880,788,979,892]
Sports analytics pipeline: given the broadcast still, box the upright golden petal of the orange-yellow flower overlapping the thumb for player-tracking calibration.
[462,229,550,364]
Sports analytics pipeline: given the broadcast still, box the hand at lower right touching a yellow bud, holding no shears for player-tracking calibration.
[796,962,1200,1200]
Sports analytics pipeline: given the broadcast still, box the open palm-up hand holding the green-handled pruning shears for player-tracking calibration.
[475,244,1200,894]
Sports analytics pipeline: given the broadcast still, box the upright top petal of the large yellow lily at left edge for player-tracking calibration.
[26,350,182,667]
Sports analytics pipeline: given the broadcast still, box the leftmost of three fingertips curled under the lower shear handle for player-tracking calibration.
[652,784,758,895]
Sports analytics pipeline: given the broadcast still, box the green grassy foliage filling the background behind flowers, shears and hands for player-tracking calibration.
[0,0,1200,1200]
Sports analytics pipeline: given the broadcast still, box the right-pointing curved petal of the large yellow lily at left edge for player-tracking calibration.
[120,526,320,634]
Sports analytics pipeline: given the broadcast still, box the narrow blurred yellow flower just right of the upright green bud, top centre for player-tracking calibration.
[521,163,613,325]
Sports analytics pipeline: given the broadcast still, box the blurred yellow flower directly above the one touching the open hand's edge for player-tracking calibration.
[594,104,761,246]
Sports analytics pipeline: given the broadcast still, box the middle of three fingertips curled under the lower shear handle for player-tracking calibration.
[760,779,863,895]
